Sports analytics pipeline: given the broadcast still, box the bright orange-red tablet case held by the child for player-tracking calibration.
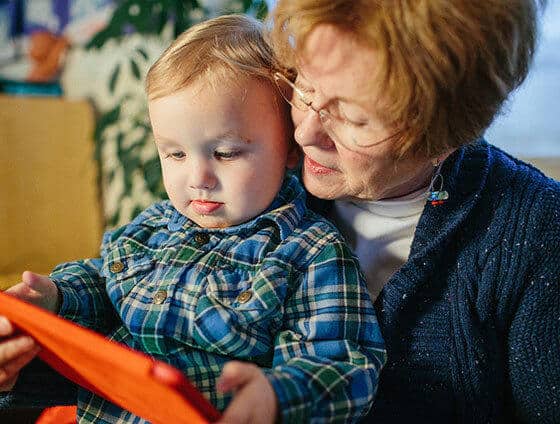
[0,293,220,424]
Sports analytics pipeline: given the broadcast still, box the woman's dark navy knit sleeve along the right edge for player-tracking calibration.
[508,184,560,423]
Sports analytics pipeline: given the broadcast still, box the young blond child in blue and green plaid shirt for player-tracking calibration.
[0,15,385,423]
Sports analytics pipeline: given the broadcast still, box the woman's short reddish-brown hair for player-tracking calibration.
[269,0,546,157]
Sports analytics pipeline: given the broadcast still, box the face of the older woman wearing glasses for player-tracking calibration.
[292,25,432,200]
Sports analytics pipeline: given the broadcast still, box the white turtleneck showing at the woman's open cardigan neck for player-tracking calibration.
[333,187,428,300]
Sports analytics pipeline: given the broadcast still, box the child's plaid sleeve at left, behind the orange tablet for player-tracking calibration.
[50,232,115,333]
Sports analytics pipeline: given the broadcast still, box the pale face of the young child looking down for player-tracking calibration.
[148,76,296,227]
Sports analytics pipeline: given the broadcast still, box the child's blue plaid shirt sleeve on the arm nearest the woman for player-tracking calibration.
[265,240,386,423]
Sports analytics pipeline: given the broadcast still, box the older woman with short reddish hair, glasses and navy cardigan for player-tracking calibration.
[264,0,560,423]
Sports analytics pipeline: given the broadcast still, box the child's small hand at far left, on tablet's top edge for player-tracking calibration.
[6,271,60,313]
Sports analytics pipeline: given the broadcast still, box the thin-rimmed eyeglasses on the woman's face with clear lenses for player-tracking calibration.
[273,72,402,150]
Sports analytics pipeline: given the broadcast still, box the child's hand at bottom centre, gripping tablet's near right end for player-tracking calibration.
[217,361,278,424]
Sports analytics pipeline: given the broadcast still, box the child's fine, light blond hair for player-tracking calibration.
[146,15,281,100]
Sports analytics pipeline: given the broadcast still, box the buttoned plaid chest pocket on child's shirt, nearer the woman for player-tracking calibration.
[193,268,285,358]
